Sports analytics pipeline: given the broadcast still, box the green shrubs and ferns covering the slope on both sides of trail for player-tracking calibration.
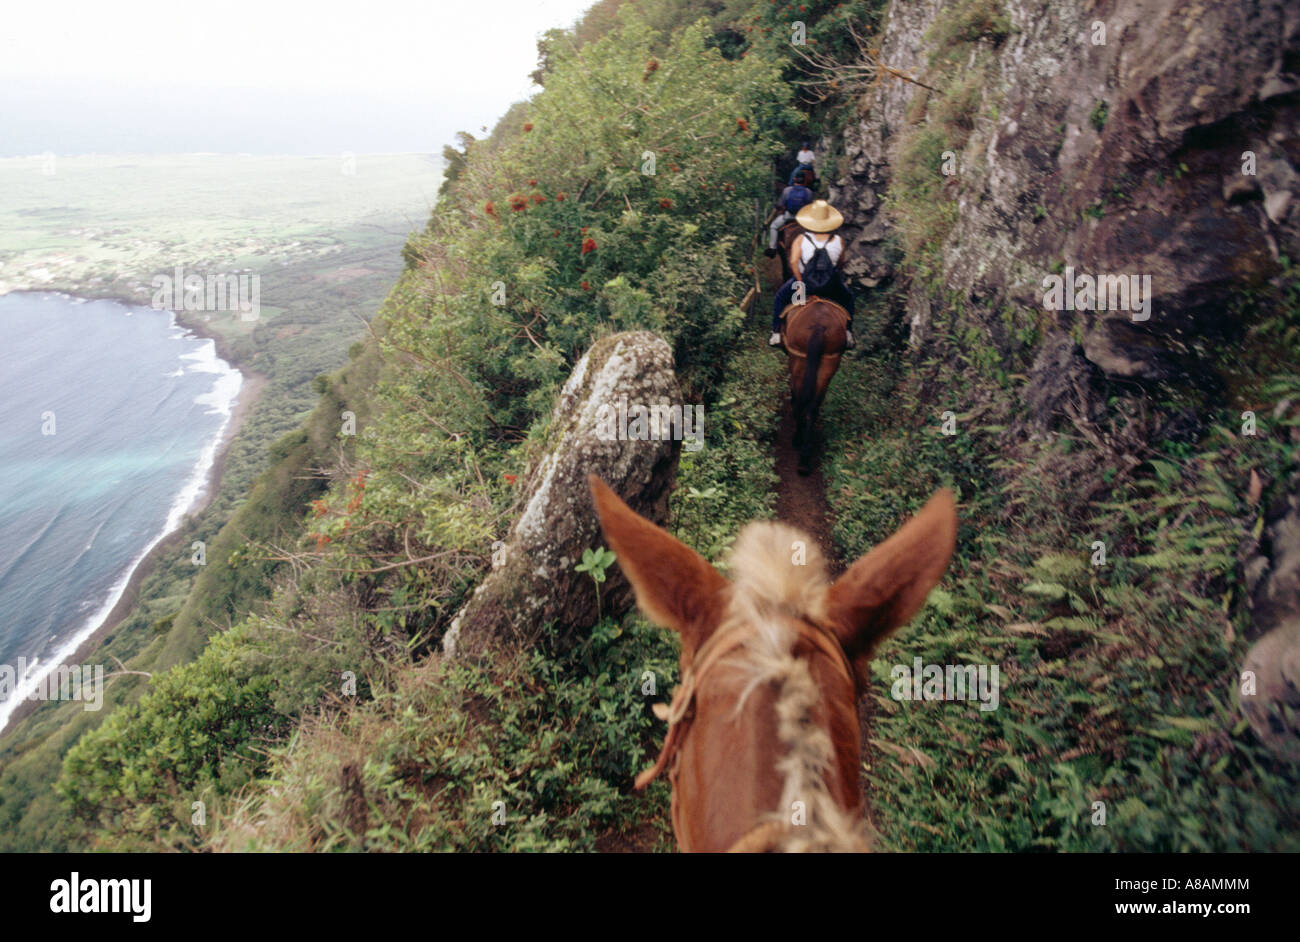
[0,0,1300,851]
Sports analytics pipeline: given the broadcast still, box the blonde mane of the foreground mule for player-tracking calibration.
[718,522,870,852]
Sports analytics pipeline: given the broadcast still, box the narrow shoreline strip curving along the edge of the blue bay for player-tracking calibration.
[0,291,269,739]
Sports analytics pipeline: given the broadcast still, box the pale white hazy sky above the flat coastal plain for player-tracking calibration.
[0,0,594,155]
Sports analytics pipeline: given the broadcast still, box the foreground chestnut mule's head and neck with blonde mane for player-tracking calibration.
[589,476,957,851]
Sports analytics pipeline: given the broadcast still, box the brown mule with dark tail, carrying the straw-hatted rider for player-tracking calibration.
[781,295,849,474]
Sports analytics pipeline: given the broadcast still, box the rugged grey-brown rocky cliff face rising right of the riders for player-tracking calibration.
[824,0,1300,755]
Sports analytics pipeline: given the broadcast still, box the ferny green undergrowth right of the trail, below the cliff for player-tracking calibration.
[826,270,1300,851]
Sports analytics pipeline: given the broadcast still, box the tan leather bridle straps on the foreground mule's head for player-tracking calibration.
[633,610,854,854]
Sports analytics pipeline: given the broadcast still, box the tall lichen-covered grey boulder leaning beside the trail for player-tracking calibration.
[443,331,681,656]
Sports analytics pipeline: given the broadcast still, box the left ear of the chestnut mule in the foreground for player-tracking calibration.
[586,474,727,644]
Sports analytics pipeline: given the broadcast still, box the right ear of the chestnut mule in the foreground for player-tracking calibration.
[827,489,957,669]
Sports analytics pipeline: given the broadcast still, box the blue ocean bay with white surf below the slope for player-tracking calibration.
[0,294,243,729]
